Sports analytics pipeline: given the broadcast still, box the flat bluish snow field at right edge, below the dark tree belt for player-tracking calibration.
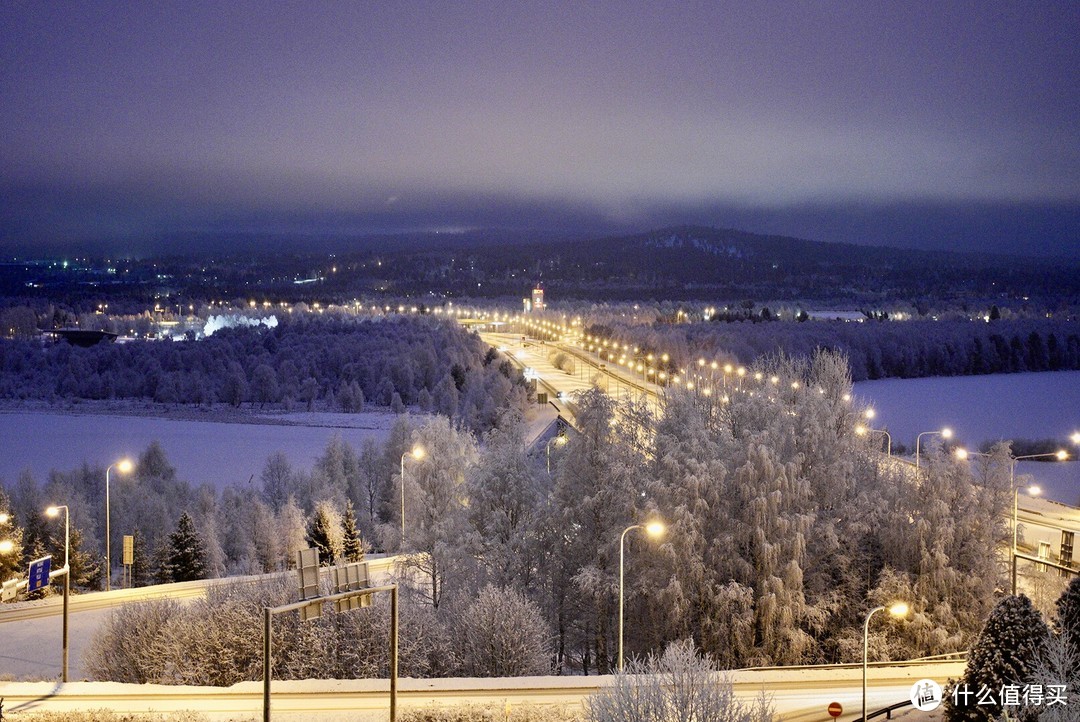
[855,371,1080,505]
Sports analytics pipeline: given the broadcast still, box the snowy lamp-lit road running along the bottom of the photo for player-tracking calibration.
[0,662,963,722]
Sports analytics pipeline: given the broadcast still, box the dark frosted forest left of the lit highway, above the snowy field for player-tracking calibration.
[0,314,527,430]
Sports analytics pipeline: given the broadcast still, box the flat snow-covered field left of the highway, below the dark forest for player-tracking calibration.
[0,410,396,489]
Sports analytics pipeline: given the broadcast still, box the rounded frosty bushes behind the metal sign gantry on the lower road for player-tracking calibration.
[85,575,549,686]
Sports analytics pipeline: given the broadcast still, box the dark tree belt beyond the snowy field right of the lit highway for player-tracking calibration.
[590,319,1080,381]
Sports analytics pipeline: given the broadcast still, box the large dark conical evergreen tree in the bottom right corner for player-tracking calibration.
[944,595,1049,722]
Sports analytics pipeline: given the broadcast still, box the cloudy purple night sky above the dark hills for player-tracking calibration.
[0,0,1080,256]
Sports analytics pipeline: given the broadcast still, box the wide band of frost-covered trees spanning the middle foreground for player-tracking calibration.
[0,353,1011,673]
